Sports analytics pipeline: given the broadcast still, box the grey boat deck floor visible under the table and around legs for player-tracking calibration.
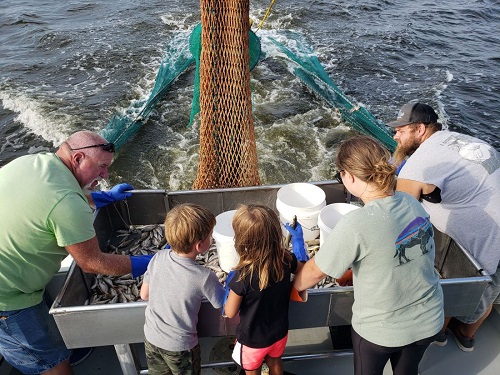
[0,305,500,375]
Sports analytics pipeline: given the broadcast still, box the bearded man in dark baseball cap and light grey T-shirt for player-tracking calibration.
[388,101,500,352]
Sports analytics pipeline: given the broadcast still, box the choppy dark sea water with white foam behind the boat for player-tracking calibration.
[0,0,500,190]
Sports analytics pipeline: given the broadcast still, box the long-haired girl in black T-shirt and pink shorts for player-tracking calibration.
[224,205,302,375]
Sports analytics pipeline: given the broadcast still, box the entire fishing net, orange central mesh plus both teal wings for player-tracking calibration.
[101,18,396,184]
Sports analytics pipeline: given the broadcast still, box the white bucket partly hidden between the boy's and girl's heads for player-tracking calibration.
[212,210,240,272]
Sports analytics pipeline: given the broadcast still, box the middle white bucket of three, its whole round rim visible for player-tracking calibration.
[276,182,326,241]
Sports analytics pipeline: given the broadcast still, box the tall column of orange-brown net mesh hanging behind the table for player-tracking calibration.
[193,0,260,189]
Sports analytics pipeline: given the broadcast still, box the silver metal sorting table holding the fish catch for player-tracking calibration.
[50,181,491,375]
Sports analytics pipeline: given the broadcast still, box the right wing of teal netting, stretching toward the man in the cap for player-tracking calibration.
[268,32,396,151]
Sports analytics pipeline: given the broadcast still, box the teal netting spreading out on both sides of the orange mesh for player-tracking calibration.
[101,24,396,151]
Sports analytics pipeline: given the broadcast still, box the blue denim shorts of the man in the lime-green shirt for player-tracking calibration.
[0,301,71,374]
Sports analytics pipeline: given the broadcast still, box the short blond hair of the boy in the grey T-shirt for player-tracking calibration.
[165,203,215,254]
